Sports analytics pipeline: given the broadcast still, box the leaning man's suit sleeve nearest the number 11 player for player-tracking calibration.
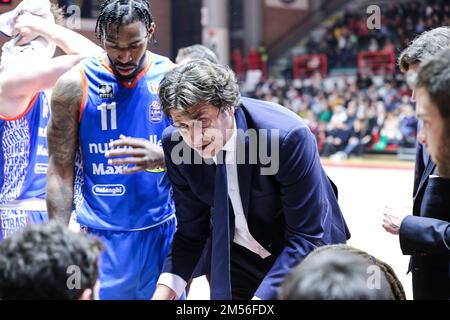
[162,135,210,282]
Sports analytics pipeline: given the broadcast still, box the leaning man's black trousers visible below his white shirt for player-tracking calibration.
[230,243,275,300]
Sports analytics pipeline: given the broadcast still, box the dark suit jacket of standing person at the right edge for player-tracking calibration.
[399,144,450,300]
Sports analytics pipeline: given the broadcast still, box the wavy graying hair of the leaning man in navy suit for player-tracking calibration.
[159,60,240,117]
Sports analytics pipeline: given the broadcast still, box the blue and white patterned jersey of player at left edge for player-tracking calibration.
[0,92,50,205]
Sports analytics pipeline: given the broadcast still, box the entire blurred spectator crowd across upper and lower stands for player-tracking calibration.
[232,0,450,159]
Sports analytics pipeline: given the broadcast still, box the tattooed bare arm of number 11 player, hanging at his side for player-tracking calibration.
[46,69,83,224]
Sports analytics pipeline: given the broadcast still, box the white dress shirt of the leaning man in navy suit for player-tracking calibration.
[158,122,270,297]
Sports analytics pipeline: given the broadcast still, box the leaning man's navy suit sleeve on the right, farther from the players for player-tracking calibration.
[255,127,346,299]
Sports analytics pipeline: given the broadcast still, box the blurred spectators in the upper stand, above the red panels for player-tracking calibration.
[305,0,450,68]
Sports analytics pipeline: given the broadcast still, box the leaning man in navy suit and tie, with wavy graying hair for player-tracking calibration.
[153,60,350,300]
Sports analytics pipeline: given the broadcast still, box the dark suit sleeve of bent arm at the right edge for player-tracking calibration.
[399,216,450,255]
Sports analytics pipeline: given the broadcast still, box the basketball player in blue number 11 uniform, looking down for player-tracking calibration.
[47,0,175,299]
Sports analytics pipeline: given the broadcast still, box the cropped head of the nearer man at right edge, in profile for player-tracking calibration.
[415,49,450,178]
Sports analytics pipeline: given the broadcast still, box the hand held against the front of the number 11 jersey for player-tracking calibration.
[105,135,165,174]
